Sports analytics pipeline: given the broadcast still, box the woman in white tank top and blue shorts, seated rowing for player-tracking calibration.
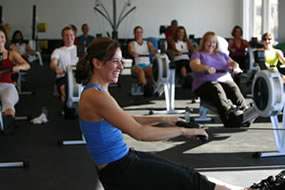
[128,26,158,90]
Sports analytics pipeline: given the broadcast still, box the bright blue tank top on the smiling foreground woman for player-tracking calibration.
[79,84,129,165]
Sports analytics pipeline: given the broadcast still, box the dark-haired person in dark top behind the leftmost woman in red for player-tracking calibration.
[10,30,35,61]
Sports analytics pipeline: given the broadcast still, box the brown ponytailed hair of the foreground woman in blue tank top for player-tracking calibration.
[75,37,120,85]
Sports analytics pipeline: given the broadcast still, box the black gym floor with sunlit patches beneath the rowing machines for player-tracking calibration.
[0,59,285,190]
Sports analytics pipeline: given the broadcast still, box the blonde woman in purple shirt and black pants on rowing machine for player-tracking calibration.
[190,32,248,127]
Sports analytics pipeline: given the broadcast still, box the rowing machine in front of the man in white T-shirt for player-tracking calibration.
[58,65,86,145]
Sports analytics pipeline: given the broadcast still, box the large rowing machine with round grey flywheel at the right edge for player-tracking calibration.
[194,50,285,158]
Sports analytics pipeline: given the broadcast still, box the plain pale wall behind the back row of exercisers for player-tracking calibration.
[0,0,242,39]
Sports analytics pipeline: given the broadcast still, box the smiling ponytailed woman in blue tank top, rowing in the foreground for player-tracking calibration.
[76,38,268,190]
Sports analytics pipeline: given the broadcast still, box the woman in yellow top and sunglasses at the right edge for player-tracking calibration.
[262,32,285,82]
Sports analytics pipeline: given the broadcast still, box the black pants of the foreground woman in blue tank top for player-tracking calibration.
[98,150,215,190]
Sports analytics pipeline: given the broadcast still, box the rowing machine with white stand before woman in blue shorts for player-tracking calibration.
[150,53,185,114]
